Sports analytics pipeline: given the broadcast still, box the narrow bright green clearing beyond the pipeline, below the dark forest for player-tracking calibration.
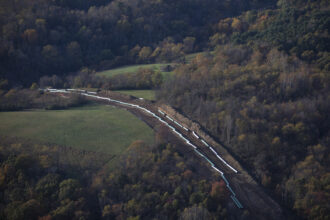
[97,63,170,77]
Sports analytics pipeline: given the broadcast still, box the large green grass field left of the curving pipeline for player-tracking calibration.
[0,105,154,155]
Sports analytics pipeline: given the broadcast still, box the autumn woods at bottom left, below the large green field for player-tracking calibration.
[0,136,232,220]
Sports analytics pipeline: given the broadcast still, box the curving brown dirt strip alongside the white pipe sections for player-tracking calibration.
[51,88,286,220]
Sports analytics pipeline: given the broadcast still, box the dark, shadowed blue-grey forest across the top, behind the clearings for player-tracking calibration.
[0,0,274,85]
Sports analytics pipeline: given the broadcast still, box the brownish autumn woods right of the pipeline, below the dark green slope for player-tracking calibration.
[158,49,330,219]
